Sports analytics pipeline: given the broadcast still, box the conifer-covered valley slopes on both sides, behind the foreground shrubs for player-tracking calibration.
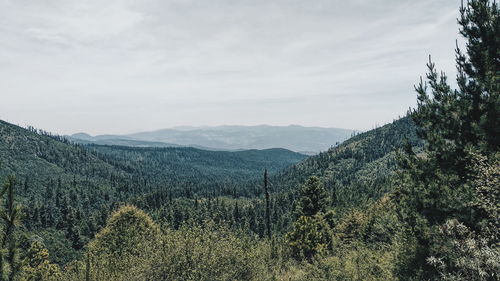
[0,111,422,272]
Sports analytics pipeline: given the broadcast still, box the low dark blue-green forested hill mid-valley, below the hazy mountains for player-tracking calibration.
[88,146,306,196]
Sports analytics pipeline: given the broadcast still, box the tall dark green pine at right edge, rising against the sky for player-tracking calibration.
[395,0,500,279]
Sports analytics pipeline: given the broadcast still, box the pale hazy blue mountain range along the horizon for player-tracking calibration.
[68,125,355,154]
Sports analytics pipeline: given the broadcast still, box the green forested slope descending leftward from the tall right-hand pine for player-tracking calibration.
[272,117,423,206]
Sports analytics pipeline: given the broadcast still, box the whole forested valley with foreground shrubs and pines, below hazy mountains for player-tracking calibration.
[0,0,500,281]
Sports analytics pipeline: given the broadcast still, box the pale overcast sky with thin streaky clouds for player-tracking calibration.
[0,0,460,135]
